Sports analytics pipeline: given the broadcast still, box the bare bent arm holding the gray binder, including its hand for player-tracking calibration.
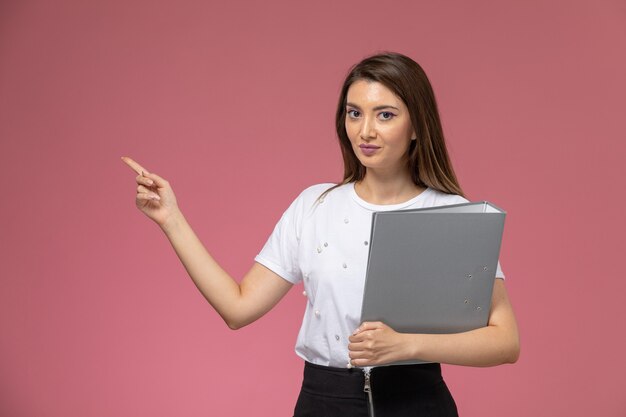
[348,279,520,366]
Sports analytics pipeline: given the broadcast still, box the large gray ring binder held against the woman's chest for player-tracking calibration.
[361,201,506,363]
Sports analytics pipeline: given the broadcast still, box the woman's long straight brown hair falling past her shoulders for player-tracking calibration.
[324,53,463,195]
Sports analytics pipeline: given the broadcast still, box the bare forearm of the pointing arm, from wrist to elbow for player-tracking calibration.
[161,211,244,327]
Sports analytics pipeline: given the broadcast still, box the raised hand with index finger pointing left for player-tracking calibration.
[122,156,180,227]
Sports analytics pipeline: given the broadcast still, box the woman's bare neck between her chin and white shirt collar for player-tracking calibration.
[354,170,424,205]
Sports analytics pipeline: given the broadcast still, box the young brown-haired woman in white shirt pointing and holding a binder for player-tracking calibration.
[123,53,519,417]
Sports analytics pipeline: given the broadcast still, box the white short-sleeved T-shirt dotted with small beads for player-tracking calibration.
[255,183,504,367]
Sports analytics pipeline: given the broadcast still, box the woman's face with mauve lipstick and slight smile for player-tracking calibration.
[346,80,415,173]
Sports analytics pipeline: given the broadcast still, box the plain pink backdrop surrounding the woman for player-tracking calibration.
[0,0,626,417]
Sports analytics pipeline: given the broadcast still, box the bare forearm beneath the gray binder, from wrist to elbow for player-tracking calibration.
[403,326,520,366]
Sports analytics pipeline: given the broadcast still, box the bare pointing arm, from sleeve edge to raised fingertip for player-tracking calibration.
[122,157,293,329]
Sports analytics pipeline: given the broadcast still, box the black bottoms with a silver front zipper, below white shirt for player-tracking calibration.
[294,362,458,417]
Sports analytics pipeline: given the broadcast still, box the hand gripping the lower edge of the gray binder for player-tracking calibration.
[348,321,406,366]
